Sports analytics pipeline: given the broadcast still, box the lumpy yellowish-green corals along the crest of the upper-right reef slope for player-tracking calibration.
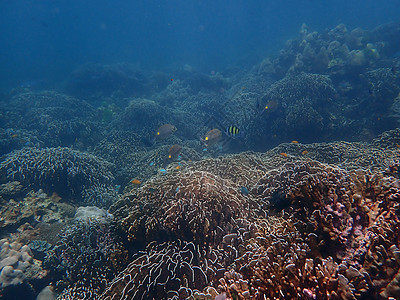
[260,23,399,78]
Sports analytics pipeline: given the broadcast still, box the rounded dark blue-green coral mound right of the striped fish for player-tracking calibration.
[246,73,343,149]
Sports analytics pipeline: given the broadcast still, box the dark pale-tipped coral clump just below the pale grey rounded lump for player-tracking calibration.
[44,218,127,299]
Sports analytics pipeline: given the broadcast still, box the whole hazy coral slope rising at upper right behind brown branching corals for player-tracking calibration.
[246,24,400,150]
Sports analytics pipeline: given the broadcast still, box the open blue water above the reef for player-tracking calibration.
[0,0,400,89]
